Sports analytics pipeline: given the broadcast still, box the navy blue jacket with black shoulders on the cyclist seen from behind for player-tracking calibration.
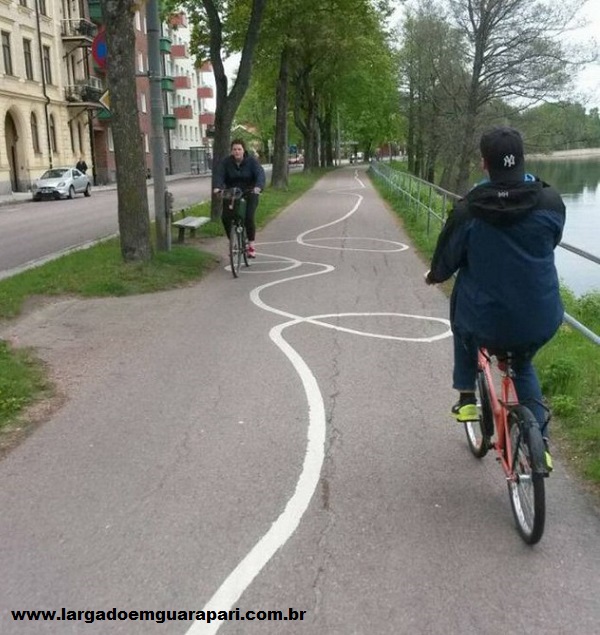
[429,175,565,351]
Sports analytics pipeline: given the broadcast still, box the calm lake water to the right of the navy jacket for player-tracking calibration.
[525,157,600,295]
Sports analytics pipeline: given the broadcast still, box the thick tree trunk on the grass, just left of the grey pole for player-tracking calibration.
[100,0,152,261]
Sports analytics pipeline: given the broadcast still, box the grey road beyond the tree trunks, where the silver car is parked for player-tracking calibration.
[0,176,210,275]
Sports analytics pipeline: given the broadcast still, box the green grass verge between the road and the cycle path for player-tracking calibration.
[0,170,327,445]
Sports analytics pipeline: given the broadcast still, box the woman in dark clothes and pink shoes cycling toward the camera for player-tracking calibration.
[213,139,265,258]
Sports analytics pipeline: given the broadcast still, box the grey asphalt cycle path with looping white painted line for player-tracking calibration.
[0,168,600,635]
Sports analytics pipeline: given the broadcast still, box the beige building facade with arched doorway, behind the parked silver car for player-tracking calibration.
[0,0,97,194]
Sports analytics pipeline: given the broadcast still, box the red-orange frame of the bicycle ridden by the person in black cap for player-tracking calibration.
[478,348,519,478]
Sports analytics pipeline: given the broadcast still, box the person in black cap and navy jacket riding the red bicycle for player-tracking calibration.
[426,127,565,429]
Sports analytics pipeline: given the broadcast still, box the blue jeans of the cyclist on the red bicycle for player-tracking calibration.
[452,333,547,434]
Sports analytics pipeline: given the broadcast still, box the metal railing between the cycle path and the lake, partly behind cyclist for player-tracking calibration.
[369,161,600,346]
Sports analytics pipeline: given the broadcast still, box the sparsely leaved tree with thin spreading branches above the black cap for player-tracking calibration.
[449,0,586,192]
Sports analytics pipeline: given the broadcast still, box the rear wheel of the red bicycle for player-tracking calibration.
[508,405,548,545]
